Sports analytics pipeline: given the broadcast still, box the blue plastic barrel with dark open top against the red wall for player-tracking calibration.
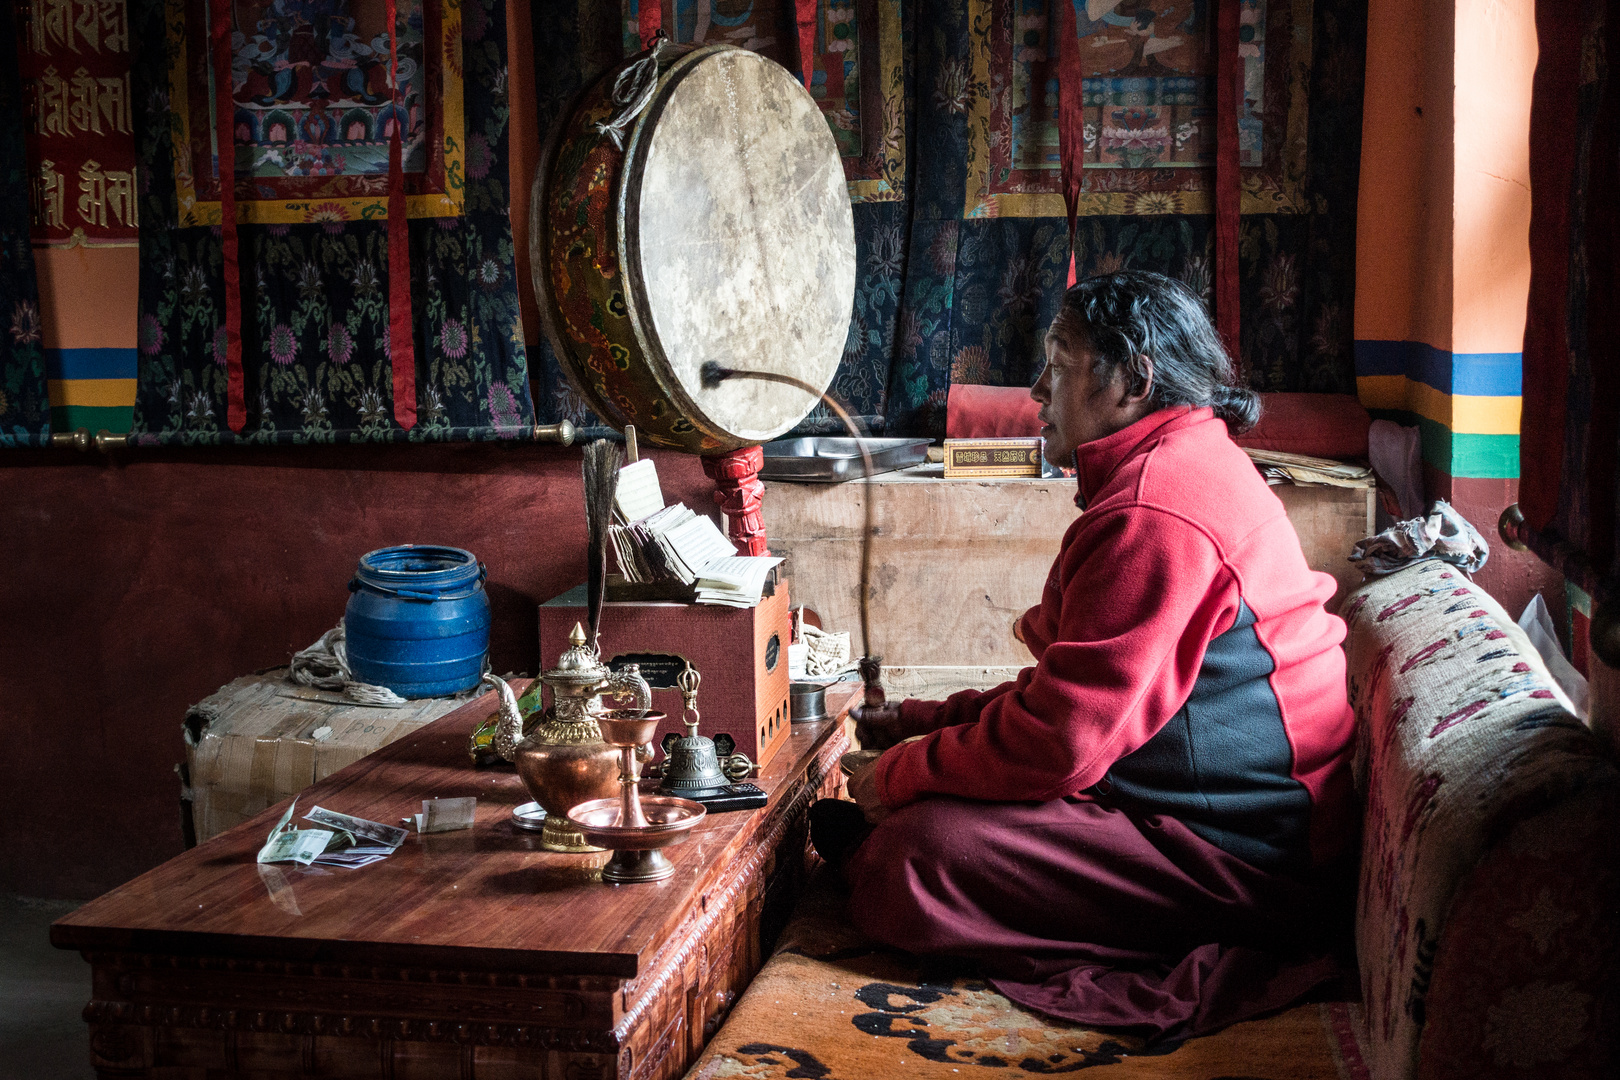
[343,544,489,698]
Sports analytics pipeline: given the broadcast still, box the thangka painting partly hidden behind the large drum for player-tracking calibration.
[622,0,906,202]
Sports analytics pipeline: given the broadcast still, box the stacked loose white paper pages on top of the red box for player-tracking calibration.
[608,458,781,607]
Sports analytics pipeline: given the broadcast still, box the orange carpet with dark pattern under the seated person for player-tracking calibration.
[687,884,1367,1080]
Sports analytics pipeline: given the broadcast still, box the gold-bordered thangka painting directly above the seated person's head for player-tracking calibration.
[961,0,1311,217]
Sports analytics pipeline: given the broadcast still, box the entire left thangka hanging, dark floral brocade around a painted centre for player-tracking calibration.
[130,0,533,445]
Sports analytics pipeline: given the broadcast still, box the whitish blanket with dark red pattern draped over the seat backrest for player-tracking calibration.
[1343,559,1615,1080]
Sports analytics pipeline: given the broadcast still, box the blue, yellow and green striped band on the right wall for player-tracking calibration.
[1356,342,1523,479]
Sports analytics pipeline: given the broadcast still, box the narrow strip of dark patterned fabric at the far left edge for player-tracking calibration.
[0,1,50,447]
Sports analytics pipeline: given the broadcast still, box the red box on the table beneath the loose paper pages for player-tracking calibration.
[539,583,792,766]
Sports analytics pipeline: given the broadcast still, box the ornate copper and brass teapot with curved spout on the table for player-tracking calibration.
[491,625,653,852]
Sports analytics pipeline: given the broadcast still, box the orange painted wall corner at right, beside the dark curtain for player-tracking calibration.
[1356,0,1563,612]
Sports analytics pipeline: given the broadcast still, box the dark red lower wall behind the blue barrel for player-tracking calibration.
[0,445,713,899]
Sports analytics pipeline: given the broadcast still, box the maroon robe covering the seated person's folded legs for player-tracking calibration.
[844,798,1349,1040]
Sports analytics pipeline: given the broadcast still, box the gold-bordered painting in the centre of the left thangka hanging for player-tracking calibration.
[165,0,467,225]
